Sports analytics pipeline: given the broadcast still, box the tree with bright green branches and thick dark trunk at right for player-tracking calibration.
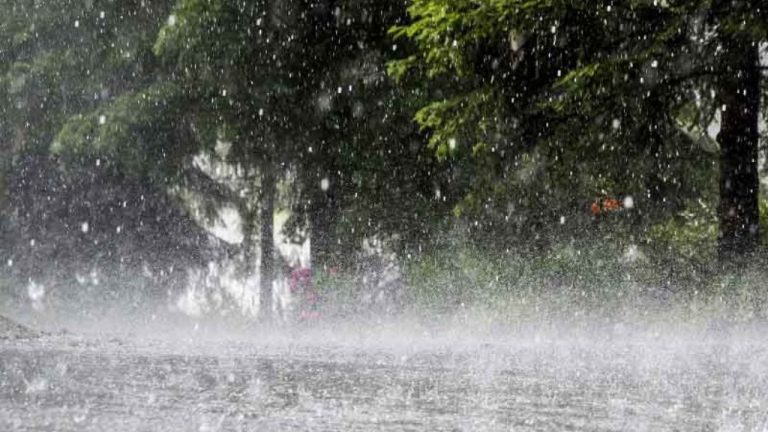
[391,0,768,258]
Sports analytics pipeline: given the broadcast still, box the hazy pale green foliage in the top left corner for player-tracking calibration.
[0,1,175,182]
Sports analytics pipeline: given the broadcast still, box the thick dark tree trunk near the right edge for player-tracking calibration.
[717,36,760,261]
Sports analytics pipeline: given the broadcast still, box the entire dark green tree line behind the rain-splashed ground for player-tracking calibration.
[0,0,768,318]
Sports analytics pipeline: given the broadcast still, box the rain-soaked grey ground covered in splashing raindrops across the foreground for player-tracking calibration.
[0,322,768,431]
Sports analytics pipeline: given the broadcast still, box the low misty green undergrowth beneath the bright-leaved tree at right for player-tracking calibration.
[406,239,768,325]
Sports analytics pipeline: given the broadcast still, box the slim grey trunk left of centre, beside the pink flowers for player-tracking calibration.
[259,164,277,321]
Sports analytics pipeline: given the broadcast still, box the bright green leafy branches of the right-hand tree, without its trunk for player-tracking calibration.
[389,0,765,253]
